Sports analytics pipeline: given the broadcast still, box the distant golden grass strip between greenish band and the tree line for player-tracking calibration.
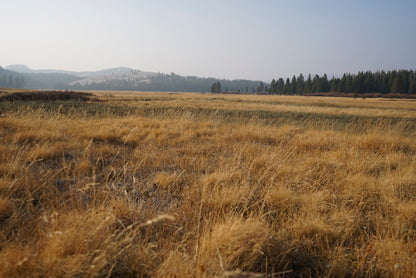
[95,92,416,117]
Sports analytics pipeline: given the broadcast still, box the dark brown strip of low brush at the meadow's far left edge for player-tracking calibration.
[0,91,98,101]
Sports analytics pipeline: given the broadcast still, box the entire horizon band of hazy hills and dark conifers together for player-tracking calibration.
[0,65,416,95]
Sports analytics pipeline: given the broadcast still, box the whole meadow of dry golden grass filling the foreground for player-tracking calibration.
[0,92,416,277]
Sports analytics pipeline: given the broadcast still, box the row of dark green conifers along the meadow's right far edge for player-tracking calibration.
[269,70,416,95]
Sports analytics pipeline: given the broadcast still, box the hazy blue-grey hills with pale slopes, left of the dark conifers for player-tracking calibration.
[0,65,260,92]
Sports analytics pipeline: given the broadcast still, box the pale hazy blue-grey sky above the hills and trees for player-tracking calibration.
[0,0,416,81]
